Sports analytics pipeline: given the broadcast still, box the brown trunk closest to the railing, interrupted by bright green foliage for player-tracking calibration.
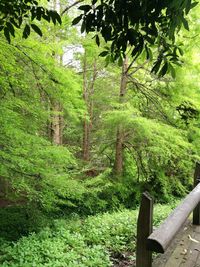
[114,57,128,176]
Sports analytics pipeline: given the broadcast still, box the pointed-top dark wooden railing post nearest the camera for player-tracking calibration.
[136,192,153,267]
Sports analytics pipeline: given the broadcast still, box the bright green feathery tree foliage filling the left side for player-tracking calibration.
[0,9,83,209]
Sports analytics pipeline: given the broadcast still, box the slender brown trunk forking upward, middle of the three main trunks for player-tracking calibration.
[83,53,97,161]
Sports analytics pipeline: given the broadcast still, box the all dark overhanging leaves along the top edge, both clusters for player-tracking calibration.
[0,0,198,76]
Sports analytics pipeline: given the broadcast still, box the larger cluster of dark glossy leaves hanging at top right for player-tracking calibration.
[73,0,197,76]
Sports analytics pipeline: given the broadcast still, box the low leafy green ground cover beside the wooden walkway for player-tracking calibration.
[0,201,180,267]
